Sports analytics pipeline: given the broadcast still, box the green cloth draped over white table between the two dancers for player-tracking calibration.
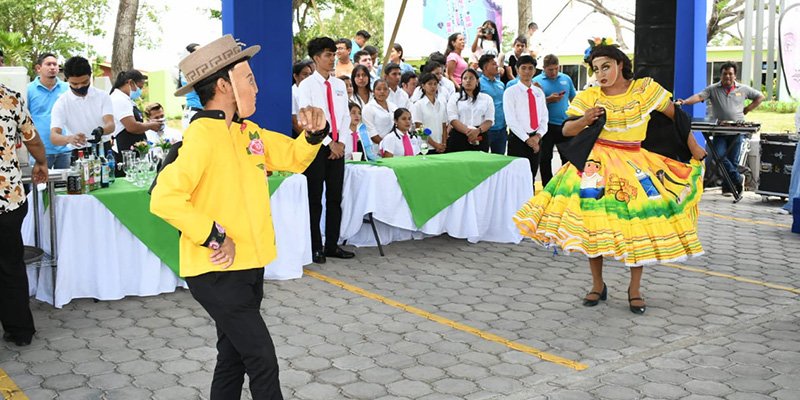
[354,151,516,227]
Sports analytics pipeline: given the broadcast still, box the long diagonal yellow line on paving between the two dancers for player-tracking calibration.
[305,270,589,371]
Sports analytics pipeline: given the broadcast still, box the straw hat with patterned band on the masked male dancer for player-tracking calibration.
[175,35,261,96]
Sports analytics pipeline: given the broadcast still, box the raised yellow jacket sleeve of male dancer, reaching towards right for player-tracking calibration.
[261,129,320,173]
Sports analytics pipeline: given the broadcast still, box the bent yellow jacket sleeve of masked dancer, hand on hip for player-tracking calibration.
[150,131,214,245]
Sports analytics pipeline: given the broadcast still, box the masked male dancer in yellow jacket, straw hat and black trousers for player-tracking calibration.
[150,35,329,400]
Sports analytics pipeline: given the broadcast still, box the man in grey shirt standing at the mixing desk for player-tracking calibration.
[677,62,764,196]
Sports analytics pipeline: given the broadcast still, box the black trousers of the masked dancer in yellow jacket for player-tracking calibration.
[186,268,283,400]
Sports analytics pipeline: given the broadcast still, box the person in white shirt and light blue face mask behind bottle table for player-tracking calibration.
[111,69,161,161]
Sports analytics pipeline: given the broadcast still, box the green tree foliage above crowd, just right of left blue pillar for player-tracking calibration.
[292,0,384,58]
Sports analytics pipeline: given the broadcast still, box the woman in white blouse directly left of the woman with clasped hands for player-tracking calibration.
[411,72,447,153]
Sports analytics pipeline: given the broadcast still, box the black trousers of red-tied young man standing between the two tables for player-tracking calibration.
[303,146,344,251]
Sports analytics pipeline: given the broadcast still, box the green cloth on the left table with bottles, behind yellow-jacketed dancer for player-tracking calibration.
[90,174,286,276]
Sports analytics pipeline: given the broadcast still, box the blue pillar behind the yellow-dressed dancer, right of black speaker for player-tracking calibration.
[674,0,707,118]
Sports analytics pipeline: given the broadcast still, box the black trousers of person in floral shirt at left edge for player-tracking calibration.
[0,202,36,341]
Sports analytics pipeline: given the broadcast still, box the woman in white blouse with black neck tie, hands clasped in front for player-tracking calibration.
[447,68,494,153]
